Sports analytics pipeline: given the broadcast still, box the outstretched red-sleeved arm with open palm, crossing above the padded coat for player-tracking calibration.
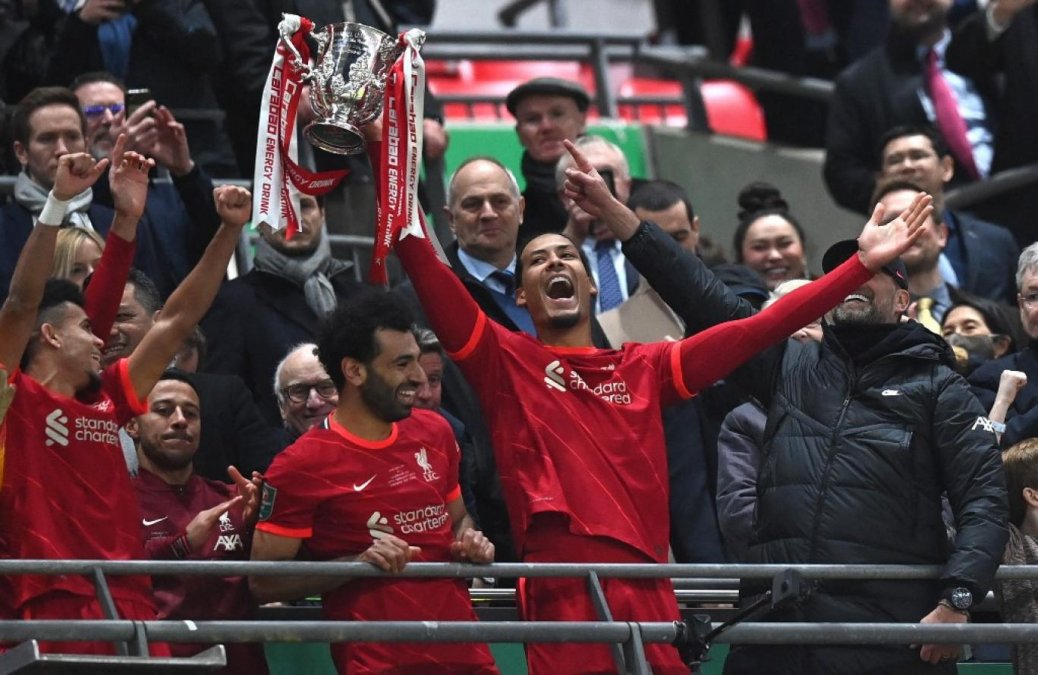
[676,193,933,395]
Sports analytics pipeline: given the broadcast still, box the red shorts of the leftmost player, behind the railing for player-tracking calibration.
[19,593,170,656]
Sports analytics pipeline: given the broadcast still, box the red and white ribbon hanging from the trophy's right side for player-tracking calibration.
[368,29,427,284]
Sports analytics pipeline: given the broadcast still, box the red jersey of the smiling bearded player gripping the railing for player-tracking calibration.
[256,409,497,673]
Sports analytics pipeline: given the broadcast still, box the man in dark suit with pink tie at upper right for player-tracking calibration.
[823,0,993,213]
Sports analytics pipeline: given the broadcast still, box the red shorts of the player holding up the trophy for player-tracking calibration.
[518,518,688,675]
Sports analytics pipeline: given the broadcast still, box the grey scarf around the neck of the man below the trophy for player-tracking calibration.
[252,228,353,319]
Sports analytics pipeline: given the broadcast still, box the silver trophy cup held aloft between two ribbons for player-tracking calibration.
[284,23,404,155]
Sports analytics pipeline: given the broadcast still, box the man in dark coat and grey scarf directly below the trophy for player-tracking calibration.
[202,194,360,427]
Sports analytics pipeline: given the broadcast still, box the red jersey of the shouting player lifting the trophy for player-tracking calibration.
[455,321,682,563]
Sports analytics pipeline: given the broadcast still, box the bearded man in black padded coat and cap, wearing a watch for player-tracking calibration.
[617,177,1007,675]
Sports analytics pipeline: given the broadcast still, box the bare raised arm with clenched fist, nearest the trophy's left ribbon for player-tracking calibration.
[130,185,251,397]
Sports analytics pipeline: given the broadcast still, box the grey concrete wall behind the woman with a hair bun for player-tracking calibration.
[647,127,866,273]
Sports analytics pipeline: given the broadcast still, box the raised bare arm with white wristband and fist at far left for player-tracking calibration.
[0,153,108,373]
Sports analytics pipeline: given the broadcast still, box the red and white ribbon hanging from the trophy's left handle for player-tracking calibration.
[252,14,349,238]
